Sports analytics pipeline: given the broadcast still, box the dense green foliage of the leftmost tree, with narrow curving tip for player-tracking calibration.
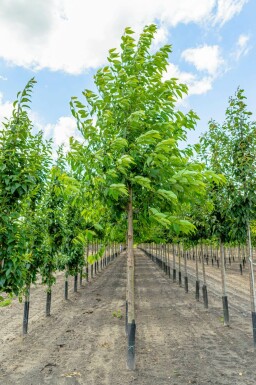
[0,78,51,295]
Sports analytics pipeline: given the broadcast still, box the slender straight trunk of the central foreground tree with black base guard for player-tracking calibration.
[126,187,136,370]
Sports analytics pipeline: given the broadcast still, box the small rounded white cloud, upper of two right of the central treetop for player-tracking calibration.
[181,45,224,76]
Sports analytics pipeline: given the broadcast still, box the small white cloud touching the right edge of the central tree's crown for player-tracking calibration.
[163,63,214,98]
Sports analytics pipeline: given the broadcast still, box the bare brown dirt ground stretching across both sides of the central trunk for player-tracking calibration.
[0,251,256,385]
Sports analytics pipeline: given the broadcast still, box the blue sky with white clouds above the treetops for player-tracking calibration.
[0,0,256,150]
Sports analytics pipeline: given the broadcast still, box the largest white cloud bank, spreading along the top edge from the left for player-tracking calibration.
[0,0,246,74]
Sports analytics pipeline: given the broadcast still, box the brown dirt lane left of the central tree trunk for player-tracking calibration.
[0,257,126,385]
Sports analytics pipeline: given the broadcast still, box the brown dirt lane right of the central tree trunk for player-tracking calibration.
[136,252,256,385]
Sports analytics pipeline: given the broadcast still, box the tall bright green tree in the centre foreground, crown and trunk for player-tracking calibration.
[71,25,222,369]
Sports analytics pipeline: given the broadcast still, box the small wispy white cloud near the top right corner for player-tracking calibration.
[214,0,249,25]
